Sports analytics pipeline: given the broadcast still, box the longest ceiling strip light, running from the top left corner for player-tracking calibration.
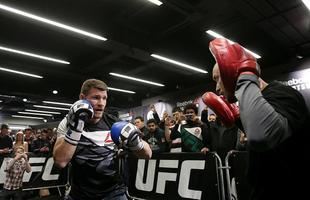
[0,4,107,41]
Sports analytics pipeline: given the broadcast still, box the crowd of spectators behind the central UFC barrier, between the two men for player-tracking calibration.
[132,104,246,160]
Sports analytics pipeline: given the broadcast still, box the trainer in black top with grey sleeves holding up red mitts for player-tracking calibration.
[205,38,310,200]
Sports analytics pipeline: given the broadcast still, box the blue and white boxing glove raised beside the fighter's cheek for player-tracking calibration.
[65,99,94,145]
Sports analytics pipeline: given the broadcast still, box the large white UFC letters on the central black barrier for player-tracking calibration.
[135,159,205,199]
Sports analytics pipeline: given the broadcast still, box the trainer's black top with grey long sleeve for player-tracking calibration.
[235,75,310,200]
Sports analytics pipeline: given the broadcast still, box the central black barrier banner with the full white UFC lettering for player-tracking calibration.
[128,153,219,200]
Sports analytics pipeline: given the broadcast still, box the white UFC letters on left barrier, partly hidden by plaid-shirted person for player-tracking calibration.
[0,157,59,184]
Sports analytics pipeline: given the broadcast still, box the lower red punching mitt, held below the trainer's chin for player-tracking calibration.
[202,92,239,128]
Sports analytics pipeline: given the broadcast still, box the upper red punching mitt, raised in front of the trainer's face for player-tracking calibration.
[209,38,259,103]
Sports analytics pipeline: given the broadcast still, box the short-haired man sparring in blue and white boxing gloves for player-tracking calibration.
[53,79,152,200]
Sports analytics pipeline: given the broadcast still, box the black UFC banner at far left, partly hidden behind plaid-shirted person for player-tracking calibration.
[0,155,68,189]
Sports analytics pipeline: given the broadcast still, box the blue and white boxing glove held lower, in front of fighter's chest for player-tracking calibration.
[111,121,143,151]
